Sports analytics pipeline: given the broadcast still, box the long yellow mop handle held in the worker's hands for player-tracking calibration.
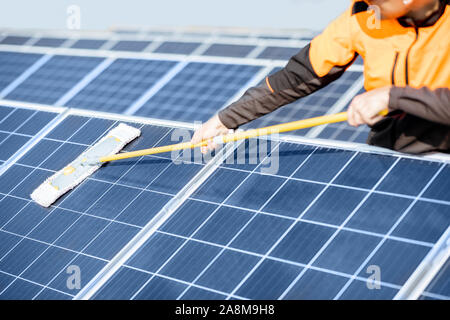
[99,110,388,162]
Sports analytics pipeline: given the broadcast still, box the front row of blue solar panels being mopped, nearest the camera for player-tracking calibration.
[0,108,450,299]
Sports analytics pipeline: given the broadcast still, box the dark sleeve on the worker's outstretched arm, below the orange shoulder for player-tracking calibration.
[219,44,357,129]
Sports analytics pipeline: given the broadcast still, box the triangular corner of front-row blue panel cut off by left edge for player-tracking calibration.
[0,106,57,165]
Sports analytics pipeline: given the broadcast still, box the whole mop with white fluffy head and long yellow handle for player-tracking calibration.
[31,110,388,207]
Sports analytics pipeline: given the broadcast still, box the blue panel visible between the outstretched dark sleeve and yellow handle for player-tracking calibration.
[246,68,362,136]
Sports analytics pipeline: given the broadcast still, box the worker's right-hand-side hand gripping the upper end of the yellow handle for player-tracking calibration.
[347,86,391,127]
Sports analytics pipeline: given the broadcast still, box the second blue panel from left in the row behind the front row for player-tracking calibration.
[6,55,103,104]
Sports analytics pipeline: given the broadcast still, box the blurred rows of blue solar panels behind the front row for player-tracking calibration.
[0,30,368,142]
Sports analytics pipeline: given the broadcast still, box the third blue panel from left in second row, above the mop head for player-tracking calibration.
[66,59,176,113]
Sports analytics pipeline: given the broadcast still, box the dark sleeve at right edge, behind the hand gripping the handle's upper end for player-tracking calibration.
[389,86,450,125]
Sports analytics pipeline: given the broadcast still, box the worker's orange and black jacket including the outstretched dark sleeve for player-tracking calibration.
[219,0,450,153]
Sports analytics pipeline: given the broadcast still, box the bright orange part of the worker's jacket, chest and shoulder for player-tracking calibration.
[309,1,450,90]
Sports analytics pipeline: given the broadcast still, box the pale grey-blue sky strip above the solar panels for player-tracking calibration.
[0,0,350,30]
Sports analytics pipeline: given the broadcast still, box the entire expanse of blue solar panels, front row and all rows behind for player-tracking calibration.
[0,32,450,299]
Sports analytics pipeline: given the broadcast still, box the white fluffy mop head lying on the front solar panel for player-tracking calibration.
[31,123,141,207]
